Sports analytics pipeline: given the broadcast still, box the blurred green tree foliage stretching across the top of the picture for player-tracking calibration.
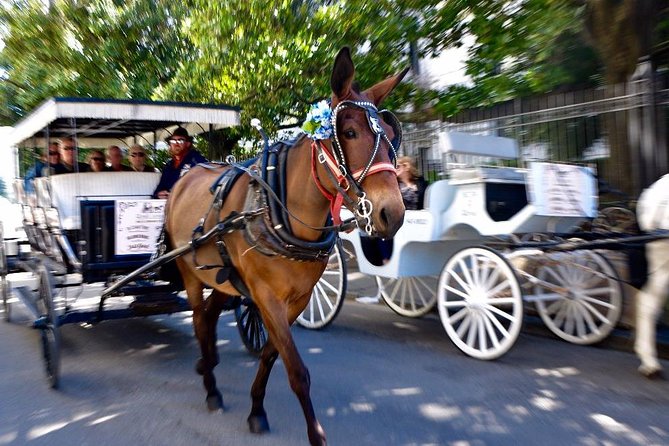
[0,0,666,134]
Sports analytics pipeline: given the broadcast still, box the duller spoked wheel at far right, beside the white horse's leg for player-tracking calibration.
[534,251,623,345]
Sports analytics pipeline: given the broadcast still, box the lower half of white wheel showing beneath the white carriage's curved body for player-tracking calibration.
[376,276,439,317]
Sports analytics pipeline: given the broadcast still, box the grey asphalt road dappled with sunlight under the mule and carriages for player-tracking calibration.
[0,288,669,446]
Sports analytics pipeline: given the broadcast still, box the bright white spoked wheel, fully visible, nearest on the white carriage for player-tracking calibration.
[438,247,523,359]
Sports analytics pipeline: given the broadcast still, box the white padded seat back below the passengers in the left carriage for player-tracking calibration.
[44,172,160,229]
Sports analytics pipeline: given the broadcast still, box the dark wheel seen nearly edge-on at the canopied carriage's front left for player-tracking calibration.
[37,265,60,389]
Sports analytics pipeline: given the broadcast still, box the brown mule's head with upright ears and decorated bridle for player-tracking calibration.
[330,48,408,238]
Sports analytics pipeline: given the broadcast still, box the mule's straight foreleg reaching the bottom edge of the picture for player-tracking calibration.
[252,293,327,445]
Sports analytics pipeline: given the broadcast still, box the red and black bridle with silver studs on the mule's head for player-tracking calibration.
[311,100,402,235]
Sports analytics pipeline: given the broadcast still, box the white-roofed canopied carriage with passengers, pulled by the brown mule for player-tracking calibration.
[0,98,264,387]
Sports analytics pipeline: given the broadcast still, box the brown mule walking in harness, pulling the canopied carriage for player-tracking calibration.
[166,48,407,445]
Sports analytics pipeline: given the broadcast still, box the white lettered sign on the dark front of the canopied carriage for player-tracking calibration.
[114,200,167,255]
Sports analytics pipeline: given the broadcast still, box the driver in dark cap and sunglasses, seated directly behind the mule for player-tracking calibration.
[153,127,207,198]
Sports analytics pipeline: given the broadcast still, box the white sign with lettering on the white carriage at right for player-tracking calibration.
[528,163,597,218]
